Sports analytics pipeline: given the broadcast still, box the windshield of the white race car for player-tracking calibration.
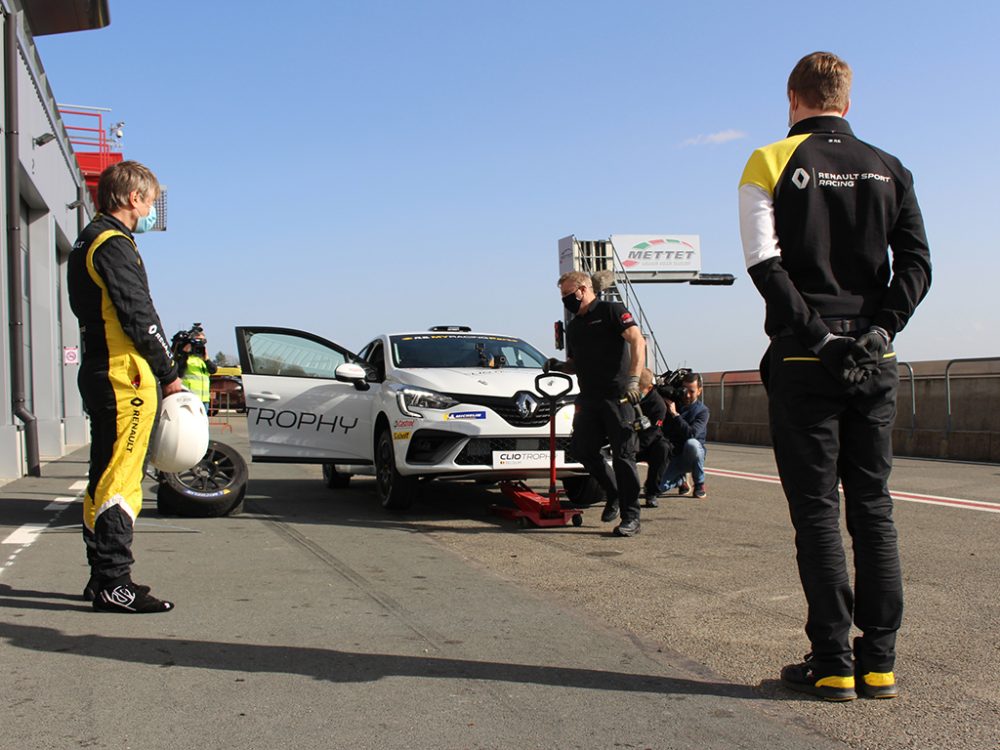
[390,333,545,369]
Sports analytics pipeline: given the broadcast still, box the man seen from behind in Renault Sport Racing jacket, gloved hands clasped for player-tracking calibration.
[739,52,931,700]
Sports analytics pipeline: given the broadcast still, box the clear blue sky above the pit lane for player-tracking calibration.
[37,0,1000,371]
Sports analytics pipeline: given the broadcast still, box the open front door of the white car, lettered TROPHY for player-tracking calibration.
[236,326,381,464]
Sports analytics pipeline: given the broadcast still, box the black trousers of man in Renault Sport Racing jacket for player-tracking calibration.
[762,337,903,675]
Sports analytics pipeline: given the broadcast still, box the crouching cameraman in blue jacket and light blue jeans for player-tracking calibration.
[660,372,709,498]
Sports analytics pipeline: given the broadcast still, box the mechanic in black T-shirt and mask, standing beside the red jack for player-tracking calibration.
[545,271,646,536]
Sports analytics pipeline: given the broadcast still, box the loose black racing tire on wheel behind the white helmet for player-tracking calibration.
[156,440,250,518]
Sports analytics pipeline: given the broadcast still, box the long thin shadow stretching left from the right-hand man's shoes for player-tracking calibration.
[0,616,762,699]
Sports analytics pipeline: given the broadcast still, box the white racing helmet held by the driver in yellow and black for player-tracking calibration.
[149,391,208,474]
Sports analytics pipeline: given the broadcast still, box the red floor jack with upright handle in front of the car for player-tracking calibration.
[492,372,583,528]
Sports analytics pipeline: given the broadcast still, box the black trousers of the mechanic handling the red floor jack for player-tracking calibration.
[570,396,639,523]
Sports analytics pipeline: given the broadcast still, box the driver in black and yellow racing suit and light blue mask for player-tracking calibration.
[67,161,183,613]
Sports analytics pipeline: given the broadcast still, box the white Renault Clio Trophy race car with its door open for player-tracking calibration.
[236,326,595,509]
